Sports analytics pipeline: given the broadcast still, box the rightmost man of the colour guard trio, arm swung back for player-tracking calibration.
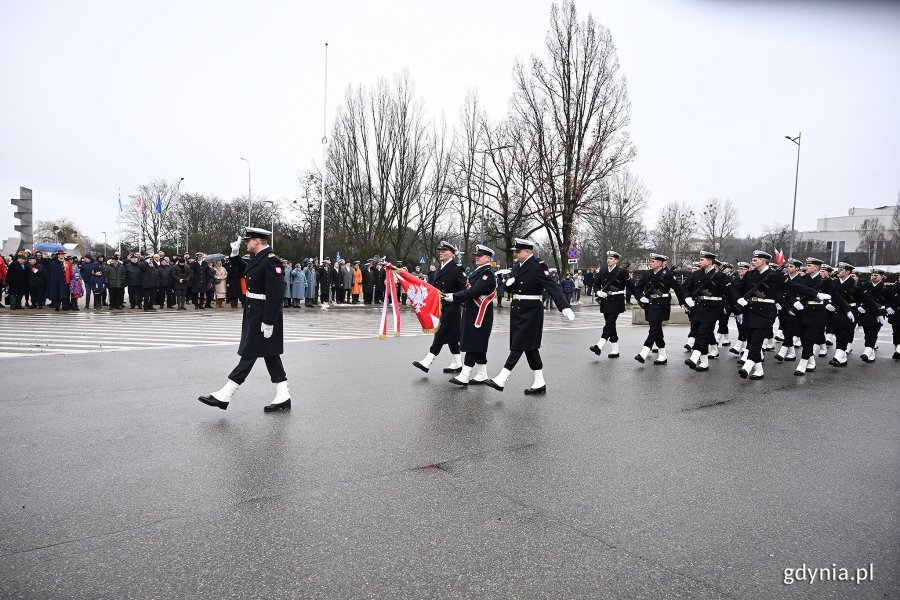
[484,238,575,395]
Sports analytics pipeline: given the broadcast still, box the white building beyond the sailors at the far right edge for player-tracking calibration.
[800,205,896,264]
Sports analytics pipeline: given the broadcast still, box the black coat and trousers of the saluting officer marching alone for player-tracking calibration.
[228,247,287,384]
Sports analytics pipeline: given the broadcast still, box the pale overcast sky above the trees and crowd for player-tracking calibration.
[0,0,900,243]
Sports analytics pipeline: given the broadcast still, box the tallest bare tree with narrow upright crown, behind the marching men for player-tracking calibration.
[514,0,635,268]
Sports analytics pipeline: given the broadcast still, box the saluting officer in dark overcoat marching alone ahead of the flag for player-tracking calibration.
[199,227,291,412]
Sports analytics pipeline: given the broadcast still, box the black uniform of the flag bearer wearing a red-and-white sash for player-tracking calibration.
[450,265,497,367]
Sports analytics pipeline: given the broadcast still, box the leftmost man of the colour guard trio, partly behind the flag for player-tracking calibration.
[413,240,466,373]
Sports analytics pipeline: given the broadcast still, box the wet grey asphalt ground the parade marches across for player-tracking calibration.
[0,306,900,600]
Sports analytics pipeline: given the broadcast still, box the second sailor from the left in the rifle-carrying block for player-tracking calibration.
[634,252,684,365]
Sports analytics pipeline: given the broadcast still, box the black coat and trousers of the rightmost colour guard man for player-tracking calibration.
[503,255,570,371]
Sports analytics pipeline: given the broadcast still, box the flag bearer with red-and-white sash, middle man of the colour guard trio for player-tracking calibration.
[443,244,497,385]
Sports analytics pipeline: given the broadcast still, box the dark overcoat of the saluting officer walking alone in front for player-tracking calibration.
[232,248,284,358]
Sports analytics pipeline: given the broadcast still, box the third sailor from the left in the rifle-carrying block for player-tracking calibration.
[683,252,737,371]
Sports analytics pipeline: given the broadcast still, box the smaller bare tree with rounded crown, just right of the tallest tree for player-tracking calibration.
[583,169,648,261]
